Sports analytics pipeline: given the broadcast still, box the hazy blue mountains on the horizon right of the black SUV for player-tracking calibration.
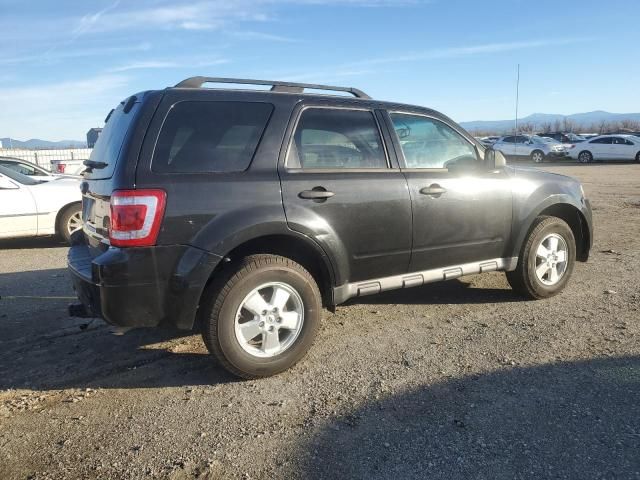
[460,110,640,133]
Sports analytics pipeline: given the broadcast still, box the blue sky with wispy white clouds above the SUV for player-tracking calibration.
[0,0,640,140]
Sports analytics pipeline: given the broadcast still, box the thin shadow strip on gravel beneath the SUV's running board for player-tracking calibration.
[345,280,525,305]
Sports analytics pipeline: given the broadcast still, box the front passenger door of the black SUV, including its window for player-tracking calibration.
[382,112,512,272]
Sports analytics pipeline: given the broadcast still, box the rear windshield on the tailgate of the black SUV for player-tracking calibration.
[86,102,140,179]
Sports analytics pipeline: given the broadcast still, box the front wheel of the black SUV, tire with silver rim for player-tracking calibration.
[507,216,576,300]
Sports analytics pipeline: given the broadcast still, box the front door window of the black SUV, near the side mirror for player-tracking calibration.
[391,113,477,168]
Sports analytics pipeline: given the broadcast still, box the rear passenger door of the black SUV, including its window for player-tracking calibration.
[280,104,411,282]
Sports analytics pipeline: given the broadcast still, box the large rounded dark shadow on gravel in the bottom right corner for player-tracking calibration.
[296,356,640,480]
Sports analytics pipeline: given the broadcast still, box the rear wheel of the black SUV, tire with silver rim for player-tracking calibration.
[202,255,322,379]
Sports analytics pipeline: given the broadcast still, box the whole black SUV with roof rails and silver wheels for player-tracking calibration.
[68,77,592,378]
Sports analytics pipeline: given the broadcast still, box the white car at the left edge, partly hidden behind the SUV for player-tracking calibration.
[0,165,82,241]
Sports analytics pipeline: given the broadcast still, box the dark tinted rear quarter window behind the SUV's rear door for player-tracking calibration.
[152,102,273,173]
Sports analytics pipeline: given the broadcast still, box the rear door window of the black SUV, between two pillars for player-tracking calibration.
[287,108,387,169]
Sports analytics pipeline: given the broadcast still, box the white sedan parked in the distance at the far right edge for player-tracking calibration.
[570,135,640,163]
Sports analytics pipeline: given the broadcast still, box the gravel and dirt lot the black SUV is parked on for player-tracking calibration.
[0,164,640,479]
